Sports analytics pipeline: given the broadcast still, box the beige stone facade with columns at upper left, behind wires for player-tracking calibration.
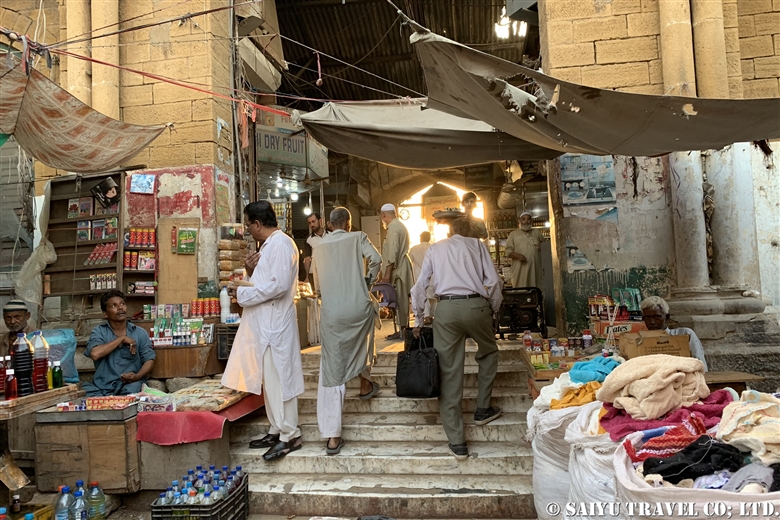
[0,0,284,191]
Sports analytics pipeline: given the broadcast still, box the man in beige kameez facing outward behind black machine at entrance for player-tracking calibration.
[504,211,542,287]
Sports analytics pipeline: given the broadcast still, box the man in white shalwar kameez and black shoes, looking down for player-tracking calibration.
[222,200,304,461]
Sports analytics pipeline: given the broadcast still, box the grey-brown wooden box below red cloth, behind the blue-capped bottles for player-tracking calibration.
[138,421,230,491]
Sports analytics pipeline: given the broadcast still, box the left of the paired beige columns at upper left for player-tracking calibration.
[65,0,92,105]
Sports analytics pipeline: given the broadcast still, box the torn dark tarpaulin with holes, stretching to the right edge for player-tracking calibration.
[411,29,780,156]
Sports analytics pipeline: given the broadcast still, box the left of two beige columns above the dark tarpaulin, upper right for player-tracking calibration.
[658,0,696,97]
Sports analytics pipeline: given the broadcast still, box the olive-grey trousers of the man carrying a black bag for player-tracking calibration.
[433,298,498,444]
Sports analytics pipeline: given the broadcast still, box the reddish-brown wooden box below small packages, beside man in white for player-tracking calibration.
[149,344,225,379]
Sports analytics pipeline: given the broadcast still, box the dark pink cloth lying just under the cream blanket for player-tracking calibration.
[596,389,732,442]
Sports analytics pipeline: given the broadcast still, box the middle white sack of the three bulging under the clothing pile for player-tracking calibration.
[565,401,626,520]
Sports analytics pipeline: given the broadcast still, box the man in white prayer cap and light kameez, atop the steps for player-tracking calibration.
[380,204,414,339]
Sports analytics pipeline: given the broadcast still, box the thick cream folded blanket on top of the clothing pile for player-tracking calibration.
[596,354,710,420]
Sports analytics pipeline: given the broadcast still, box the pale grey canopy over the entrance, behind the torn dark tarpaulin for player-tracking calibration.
[293,99,561,169]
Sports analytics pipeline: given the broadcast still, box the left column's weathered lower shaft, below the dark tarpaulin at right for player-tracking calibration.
[669,152,710,292]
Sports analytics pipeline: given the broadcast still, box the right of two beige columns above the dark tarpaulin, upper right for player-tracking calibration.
[692,0,729,99]
